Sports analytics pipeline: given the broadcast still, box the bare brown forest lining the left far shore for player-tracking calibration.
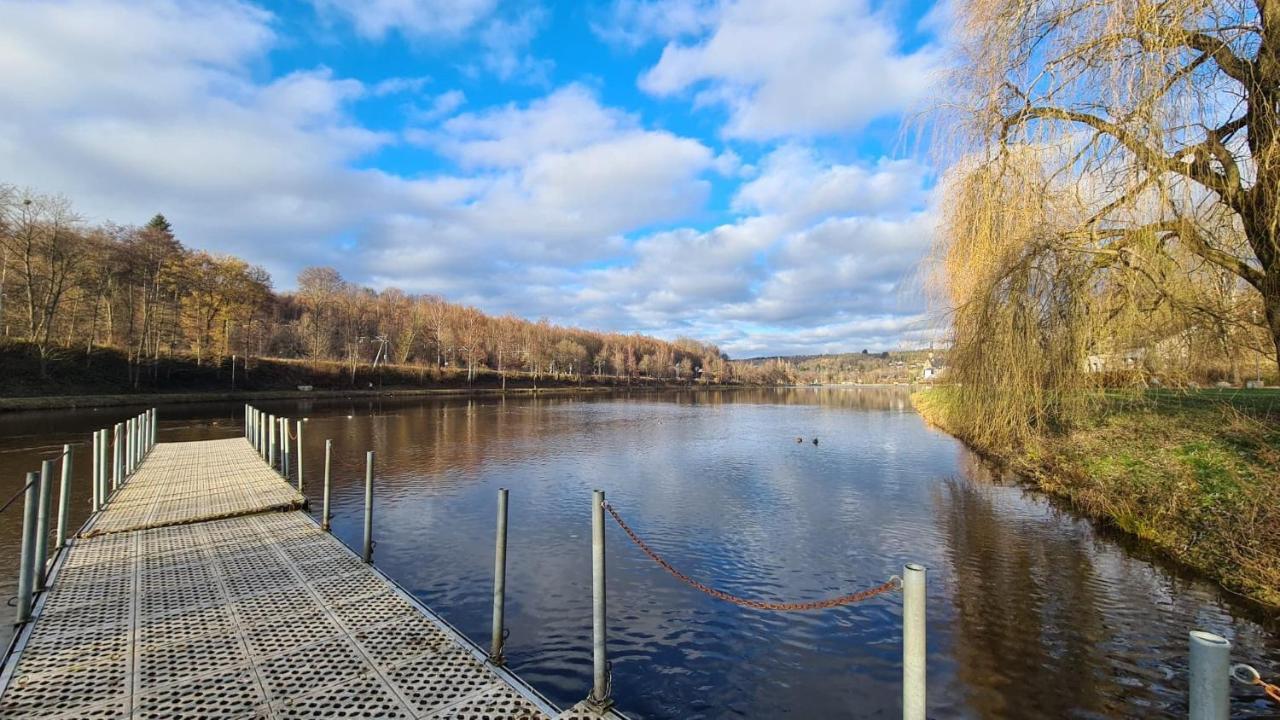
[0,184,757,388]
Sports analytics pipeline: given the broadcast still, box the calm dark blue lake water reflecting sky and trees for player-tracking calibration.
[0,388,1280,719]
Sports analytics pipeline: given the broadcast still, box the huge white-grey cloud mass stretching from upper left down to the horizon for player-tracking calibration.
[0,0,933,355]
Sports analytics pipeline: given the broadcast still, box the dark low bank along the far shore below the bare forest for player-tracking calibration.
[0,345,711,411]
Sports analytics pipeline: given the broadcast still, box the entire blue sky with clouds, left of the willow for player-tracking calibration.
[0,0,945,357]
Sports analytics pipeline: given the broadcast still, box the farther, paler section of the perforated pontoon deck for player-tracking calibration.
[83,438,306,536]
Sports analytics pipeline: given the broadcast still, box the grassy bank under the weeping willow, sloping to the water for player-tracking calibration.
[911,387,1280,606]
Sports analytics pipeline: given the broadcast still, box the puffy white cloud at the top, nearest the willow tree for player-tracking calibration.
[640,0,940,140]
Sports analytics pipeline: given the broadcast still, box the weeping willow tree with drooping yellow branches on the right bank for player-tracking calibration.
[936,0,1280,442]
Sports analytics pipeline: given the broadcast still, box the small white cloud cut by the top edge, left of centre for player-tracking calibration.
[311,0,497,40]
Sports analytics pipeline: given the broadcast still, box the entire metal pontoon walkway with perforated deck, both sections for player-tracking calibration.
[0,438,613,720]
